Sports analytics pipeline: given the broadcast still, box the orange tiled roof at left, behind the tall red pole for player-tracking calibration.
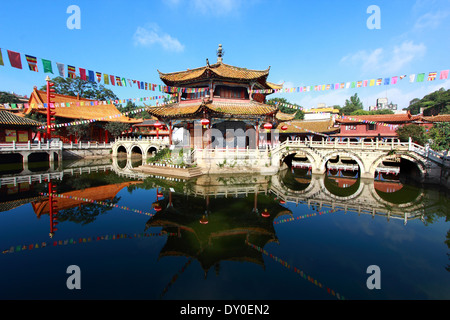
[26,88,142,123]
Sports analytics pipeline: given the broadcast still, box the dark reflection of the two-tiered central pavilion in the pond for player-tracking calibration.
[146,186,291,276]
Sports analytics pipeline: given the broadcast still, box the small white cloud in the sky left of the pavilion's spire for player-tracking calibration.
[133,24,184,52]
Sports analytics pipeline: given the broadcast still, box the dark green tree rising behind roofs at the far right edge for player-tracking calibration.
[406,88,450,116]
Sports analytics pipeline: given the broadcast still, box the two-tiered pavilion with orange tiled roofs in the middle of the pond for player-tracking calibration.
[148,45,282,148]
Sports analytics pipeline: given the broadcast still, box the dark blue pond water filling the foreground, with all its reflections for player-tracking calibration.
[0,160,450,300]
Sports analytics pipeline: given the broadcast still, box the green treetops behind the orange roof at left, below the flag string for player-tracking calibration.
[40,77,118,101]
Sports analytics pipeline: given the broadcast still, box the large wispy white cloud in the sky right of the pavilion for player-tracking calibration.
[341,41,427,73]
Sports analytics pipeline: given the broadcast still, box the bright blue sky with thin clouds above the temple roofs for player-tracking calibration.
[0,0,450,109]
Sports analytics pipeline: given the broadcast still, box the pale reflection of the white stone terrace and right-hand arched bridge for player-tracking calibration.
[176,171,425,224]
